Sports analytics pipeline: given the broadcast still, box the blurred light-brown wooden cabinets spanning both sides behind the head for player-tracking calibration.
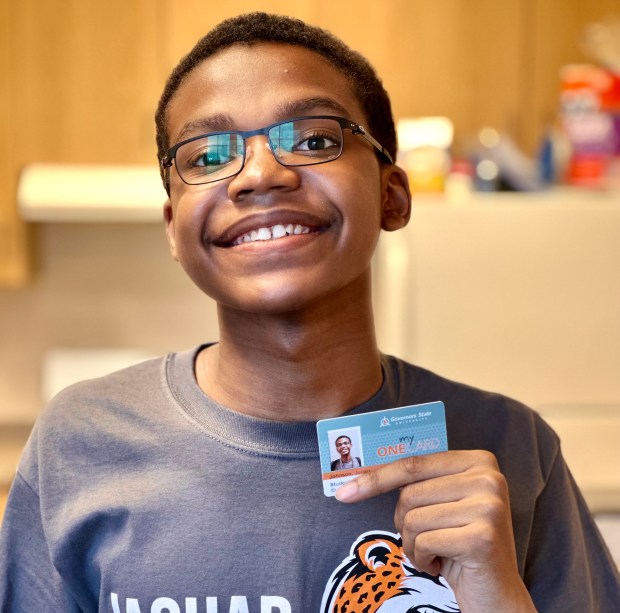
[0,0,620,285]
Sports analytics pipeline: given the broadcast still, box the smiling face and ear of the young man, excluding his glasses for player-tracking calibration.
[166,43,408,314]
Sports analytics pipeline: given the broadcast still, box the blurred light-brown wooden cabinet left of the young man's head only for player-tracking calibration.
[0,0,166,286]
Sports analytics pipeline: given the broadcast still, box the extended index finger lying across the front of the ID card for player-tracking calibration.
[336,451,497,502]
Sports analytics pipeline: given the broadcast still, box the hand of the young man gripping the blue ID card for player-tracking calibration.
[336,451,535,613]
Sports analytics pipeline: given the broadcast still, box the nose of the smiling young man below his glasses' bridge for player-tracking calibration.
[228,135,300,200]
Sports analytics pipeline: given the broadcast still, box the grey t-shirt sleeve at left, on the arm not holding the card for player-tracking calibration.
[0,473,79,613]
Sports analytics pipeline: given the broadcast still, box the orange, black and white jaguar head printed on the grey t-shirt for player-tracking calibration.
[321,531,460,613]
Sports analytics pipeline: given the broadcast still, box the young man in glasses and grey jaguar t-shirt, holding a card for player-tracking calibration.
[0,14,620,613]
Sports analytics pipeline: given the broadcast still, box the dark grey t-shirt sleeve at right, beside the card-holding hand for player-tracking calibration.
[524,451,620,613]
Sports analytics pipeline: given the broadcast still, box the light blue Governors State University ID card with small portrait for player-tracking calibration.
[316,401,448,496]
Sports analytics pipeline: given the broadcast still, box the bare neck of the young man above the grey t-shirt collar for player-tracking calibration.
[196,272,382,421]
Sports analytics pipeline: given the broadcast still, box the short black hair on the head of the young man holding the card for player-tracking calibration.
[155,12,397,188]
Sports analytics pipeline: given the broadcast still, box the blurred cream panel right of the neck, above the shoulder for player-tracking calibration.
[374,192,620,407]
